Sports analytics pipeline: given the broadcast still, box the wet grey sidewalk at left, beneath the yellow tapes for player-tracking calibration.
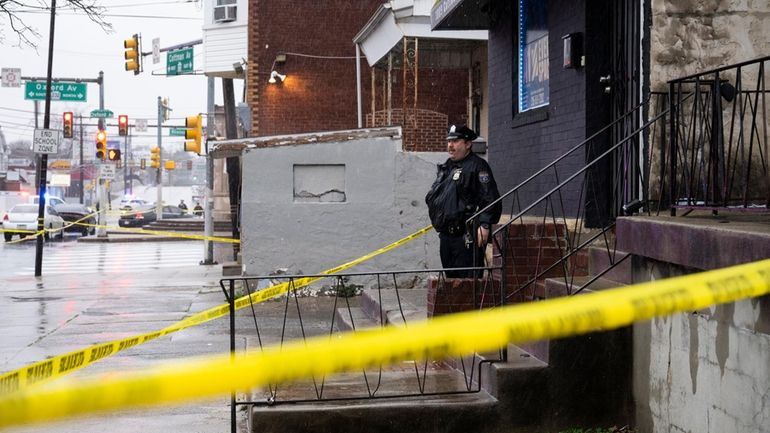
[0,241,245,433]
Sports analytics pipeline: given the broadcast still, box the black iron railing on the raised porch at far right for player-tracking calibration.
[668,57,770,215]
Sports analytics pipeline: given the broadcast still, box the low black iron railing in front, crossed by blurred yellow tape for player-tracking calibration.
[220,268,504,425]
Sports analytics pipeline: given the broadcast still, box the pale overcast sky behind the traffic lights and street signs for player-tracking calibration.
[0,0,242,151]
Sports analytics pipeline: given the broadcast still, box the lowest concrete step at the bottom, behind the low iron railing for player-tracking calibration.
[248,369,500,433]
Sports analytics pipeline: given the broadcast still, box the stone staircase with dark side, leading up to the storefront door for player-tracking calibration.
[248,248,633,433]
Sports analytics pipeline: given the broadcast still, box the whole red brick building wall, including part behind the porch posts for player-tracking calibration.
[246,0,468,141]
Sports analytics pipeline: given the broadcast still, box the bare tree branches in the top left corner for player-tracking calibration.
[0,0,112,48]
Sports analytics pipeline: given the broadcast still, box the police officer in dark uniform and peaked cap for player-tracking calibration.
[425,125,502,278]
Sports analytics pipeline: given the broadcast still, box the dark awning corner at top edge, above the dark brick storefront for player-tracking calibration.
[430,0,491,30]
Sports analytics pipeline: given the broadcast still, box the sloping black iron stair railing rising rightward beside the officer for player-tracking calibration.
[467,93,672,302]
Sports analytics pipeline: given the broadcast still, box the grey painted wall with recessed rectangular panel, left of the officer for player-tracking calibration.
[241,128,445,278]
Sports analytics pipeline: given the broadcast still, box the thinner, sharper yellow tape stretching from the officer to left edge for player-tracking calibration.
[0,226,432,395]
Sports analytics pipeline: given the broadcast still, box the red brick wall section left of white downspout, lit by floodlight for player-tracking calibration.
[246,0,381,136]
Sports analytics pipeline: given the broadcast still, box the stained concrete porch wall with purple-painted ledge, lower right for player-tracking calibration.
[617,214,770,433]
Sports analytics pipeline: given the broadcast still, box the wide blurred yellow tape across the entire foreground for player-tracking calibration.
[0,255,770,428]
